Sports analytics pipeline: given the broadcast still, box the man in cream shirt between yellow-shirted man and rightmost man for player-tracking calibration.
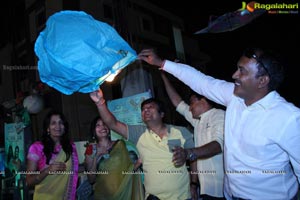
[161,73,225,200]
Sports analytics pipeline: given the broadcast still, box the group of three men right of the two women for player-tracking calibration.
[90,48,300,200]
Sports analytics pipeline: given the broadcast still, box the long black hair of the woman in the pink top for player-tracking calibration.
[41,110,73,164]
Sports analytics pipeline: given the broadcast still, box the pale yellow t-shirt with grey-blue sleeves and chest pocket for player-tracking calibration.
[128,125,194,200]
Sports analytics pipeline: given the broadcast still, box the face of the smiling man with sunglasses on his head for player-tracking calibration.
[232,56,261,105]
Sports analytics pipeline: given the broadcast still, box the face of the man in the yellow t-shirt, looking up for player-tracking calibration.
[142,102,164,123]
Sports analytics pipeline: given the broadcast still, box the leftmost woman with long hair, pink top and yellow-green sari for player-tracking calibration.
[26,111,78,200]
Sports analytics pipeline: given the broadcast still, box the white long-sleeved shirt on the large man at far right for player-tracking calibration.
[164,61,300,200]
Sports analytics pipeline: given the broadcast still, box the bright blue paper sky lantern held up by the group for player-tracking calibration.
[34,11,137,95]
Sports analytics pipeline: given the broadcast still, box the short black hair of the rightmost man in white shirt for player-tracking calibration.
[242,48,284,91]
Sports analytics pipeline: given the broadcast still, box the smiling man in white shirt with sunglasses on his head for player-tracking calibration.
[139,48,300,200]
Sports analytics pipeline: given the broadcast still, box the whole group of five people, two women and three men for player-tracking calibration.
[26,48,300,200]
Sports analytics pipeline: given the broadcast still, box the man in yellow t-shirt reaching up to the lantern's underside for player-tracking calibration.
[90,89,196,200]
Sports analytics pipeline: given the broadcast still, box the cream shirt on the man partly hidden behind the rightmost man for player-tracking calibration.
[176,101,225,197]
